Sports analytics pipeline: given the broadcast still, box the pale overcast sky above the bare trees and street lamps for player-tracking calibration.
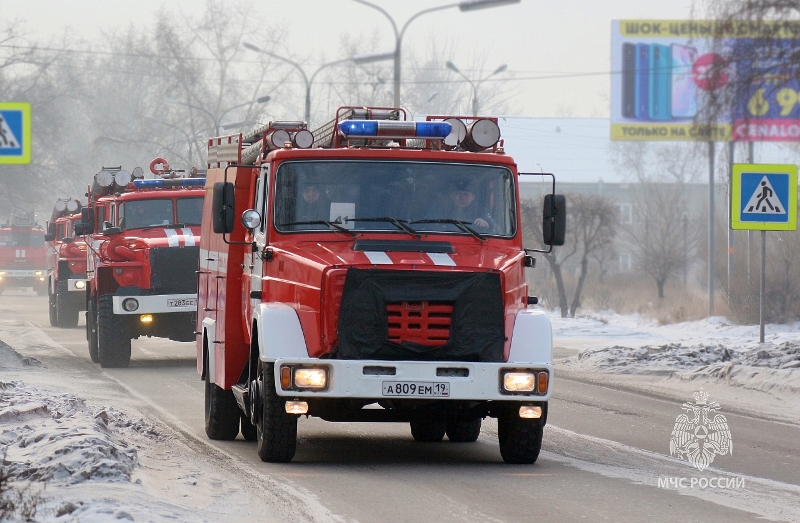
[0,0,692,117]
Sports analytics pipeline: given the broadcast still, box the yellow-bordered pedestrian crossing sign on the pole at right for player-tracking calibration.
[731,164,797,231]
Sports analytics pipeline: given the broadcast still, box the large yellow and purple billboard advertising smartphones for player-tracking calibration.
[611,20,800,141]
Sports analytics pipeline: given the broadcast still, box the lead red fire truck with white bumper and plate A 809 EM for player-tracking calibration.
[197,107,566,463]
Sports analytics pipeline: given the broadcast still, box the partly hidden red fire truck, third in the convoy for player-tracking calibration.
[45,199,87,328]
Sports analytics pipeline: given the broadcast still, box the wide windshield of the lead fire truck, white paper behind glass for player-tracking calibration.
[274,160,517,237]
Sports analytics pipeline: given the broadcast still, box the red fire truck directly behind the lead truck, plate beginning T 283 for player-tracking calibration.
[81,164,205,367]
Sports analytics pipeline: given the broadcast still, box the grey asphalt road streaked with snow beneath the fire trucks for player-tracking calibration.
[0,294,800,523]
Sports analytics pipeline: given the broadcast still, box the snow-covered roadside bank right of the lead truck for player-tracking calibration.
[551,312,800,423]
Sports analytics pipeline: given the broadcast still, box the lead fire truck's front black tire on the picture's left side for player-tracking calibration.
[255,361,297,463]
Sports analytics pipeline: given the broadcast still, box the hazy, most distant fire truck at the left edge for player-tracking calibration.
[0,212,47,296]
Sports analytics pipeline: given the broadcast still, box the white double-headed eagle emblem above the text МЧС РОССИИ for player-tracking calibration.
[669,388,733,472]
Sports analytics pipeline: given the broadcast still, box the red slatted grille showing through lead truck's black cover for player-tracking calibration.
[386,301,453,347]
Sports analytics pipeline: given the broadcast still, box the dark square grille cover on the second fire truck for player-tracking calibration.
[150,246,200,294]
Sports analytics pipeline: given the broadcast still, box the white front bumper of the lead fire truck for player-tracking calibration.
[275,358,553,402]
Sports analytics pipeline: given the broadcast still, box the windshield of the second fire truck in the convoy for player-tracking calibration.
[119,197,203,229]
